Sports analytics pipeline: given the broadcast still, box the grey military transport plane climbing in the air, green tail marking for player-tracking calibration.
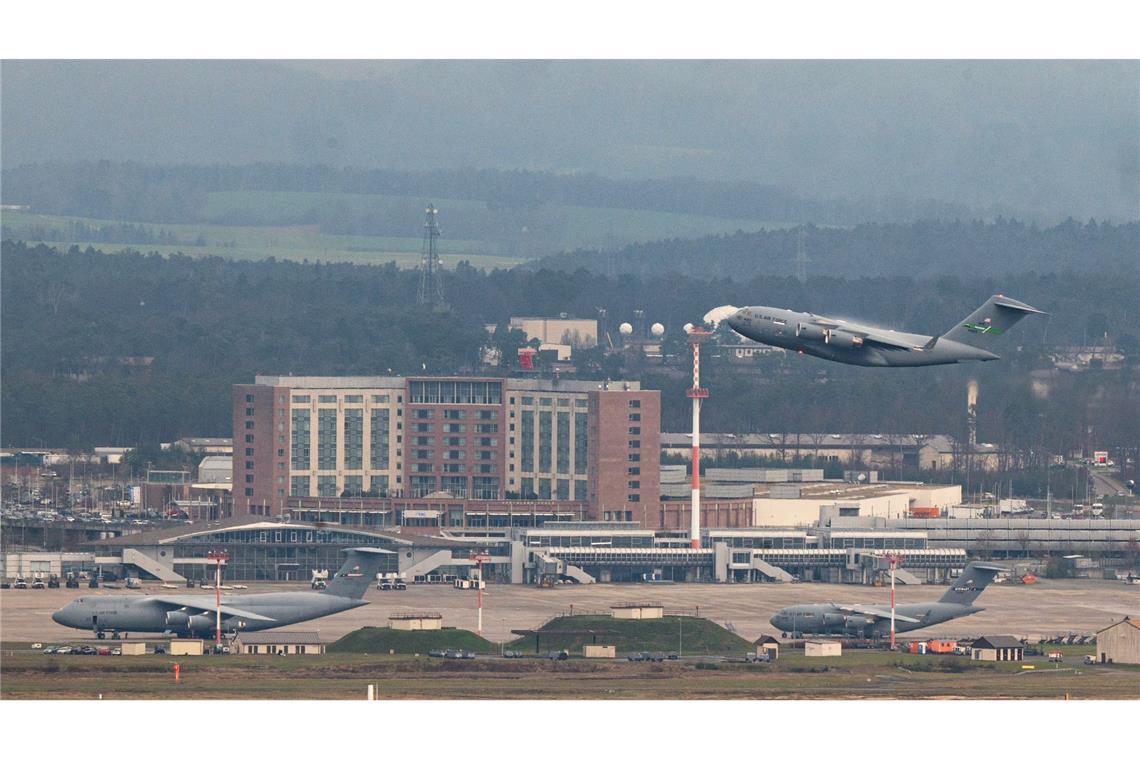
[725,295,1045,367]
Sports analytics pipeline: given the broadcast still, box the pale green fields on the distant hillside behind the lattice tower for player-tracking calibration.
[3,190,783,269]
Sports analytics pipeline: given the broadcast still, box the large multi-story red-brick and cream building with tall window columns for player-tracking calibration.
[234,376,660,524]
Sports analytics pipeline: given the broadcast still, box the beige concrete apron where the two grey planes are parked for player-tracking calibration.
[0,580,1140,641]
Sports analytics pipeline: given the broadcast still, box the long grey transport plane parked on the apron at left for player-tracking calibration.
[51,548,389,638]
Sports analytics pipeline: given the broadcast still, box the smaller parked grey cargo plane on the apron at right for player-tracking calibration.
[770,562,1005,638]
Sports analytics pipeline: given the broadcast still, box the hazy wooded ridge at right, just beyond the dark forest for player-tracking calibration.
[527,219,1140,280]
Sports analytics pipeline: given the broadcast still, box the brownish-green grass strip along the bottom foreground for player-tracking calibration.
[0,645,1140,700]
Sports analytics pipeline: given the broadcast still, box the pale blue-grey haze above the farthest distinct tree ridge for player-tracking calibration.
[0,60,1140,220]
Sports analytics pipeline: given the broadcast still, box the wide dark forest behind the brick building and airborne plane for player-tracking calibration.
[0,240,1140,460]
